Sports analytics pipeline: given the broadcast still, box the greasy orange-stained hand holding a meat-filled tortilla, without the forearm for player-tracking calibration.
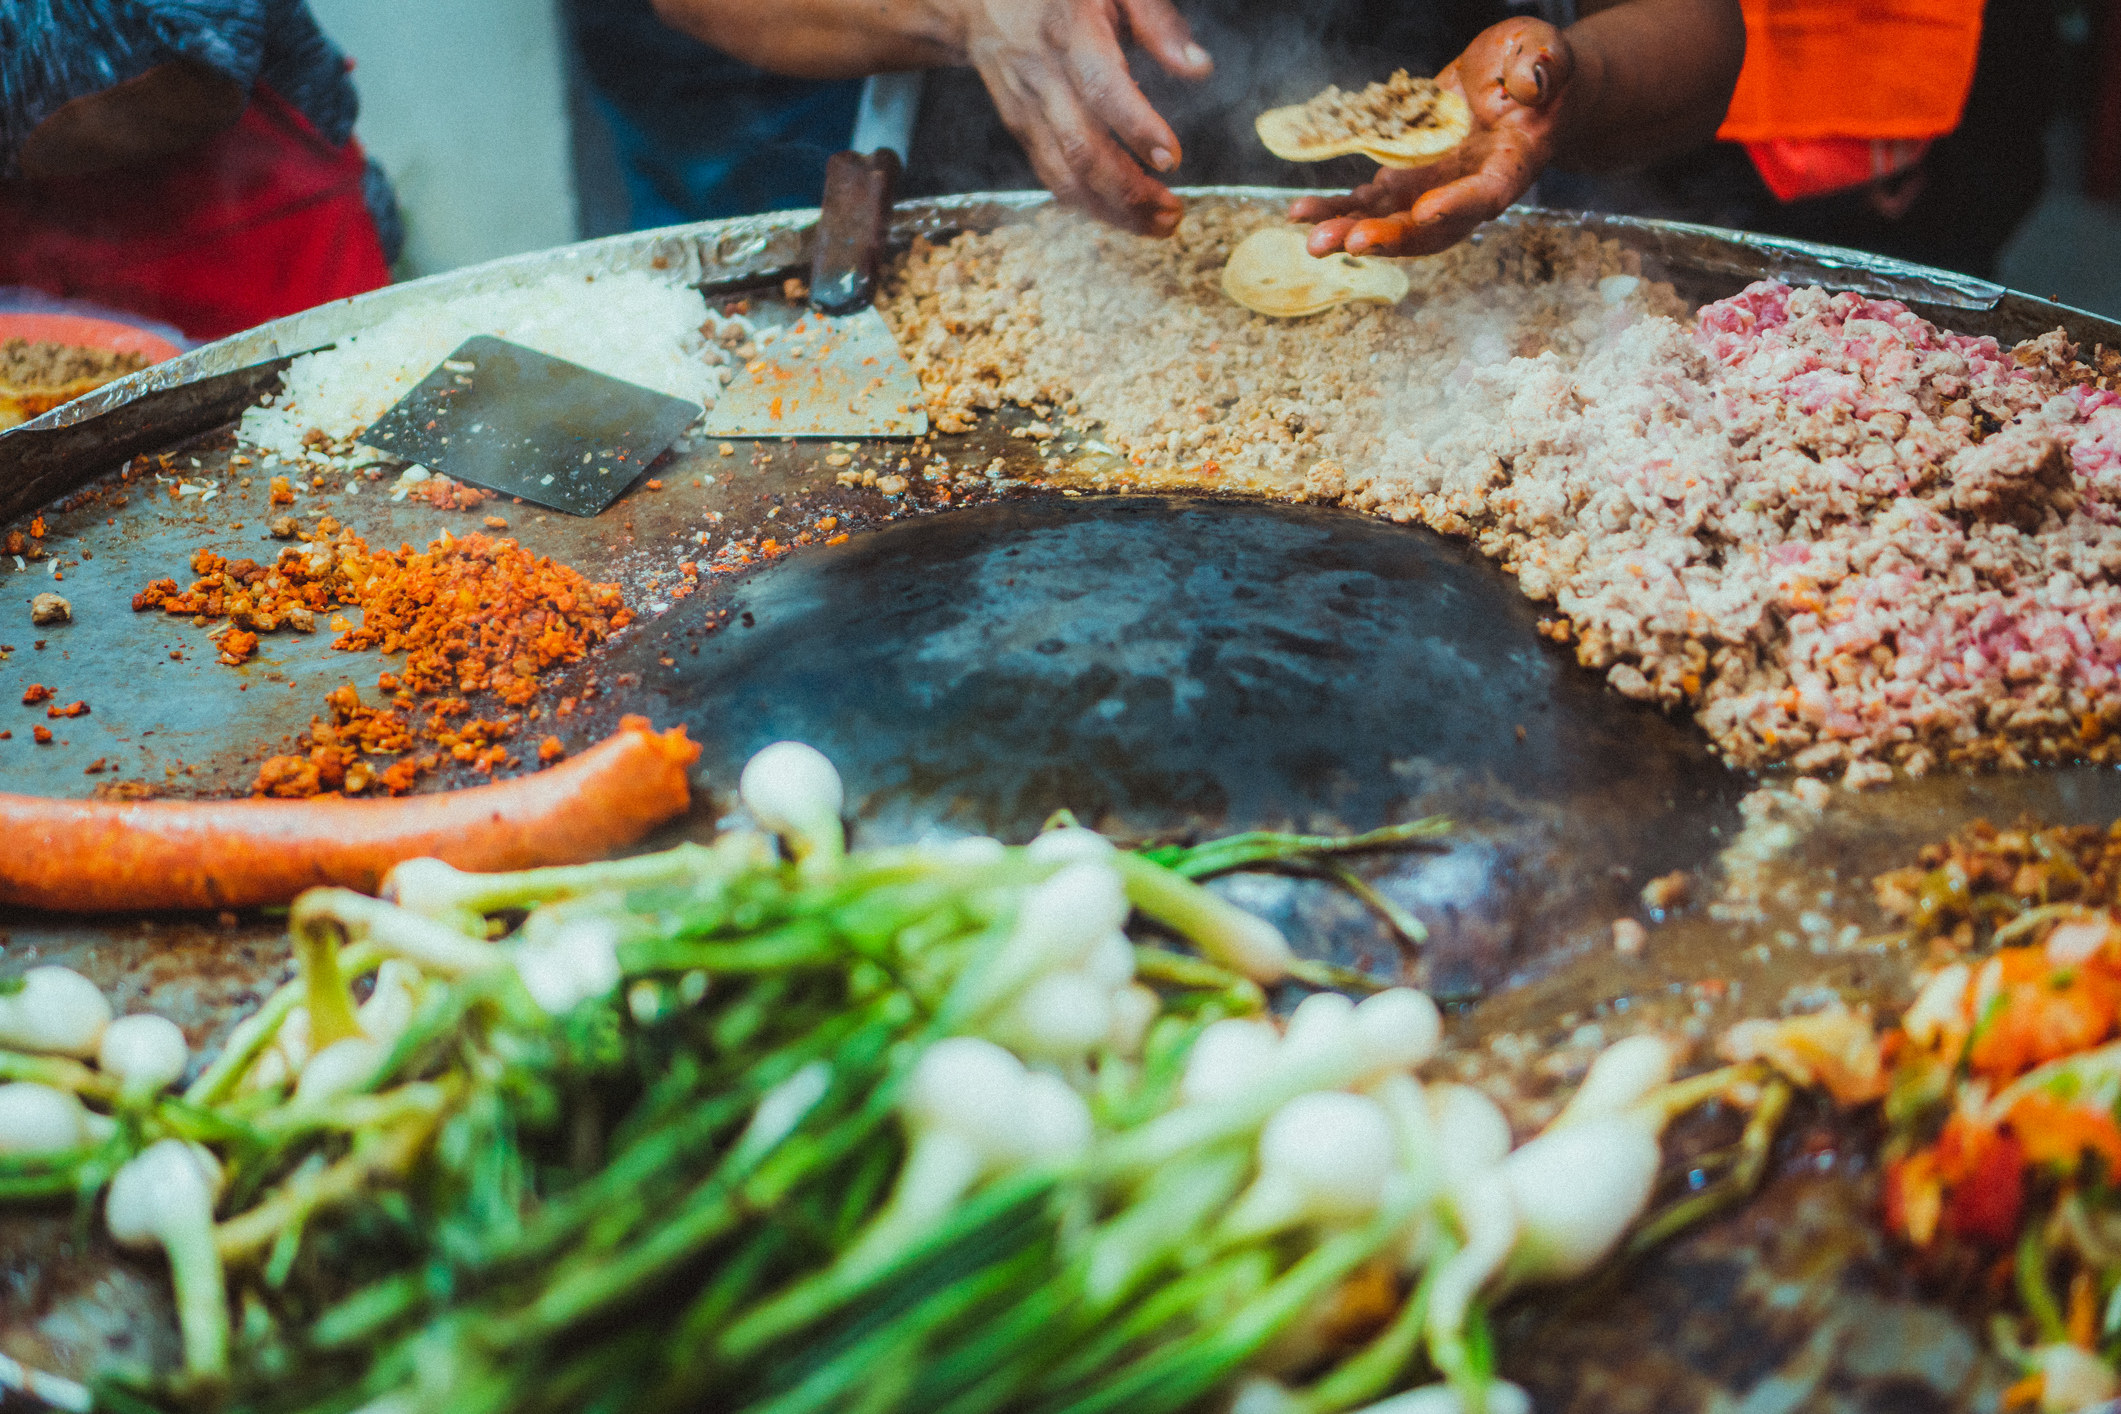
[1290,19,1576,254]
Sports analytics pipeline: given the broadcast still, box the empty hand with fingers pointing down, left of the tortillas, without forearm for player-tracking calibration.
[946,0,1213,235]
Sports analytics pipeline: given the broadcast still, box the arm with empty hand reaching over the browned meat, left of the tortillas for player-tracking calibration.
[655,0,1211,235]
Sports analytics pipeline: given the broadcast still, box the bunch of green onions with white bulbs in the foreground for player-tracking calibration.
[0,744,1718,1414]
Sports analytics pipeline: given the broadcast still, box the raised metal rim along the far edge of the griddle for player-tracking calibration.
[0,187,2121,534]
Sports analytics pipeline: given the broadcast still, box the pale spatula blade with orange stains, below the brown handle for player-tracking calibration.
[706,310,927,437]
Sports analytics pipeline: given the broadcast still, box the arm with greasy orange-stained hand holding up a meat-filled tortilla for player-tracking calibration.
[1290,0,1746,254]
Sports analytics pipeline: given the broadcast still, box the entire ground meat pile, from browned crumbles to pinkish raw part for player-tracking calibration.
[887,208,2121,782]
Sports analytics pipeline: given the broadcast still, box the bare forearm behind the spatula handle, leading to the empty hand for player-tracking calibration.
[636,0,963,78]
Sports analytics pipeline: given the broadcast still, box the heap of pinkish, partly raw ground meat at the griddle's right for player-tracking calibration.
[1374,284,2121,782]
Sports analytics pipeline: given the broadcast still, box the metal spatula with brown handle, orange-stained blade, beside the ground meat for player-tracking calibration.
[706,148,927,437]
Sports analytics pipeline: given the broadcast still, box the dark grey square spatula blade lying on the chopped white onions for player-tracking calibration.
[361,335,700,515]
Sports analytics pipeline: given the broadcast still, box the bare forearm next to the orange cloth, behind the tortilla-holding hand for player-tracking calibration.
[1555,0,1746,172]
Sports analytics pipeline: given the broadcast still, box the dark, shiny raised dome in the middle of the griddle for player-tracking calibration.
[593,496,1743,994]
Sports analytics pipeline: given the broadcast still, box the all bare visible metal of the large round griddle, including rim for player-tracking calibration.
[0,189,2121,1410]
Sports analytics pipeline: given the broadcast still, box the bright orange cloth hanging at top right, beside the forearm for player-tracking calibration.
[1716,0,1981,142]
